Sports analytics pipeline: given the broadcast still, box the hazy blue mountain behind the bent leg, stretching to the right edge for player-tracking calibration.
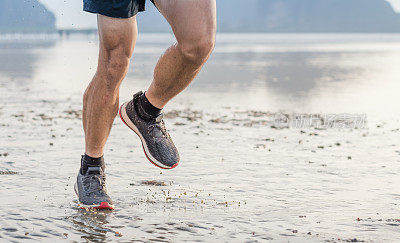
[138,0,400,32]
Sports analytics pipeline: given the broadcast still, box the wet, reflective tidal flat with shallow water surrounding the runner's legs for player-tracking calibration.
[0,34,400,242]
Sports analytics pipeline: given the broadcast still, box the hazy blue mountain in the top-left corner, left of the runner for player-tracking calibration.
[0,0,56,32]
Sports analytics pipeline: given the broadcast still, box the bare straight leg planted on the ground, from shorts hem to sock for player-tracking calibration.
[83,15,137,157]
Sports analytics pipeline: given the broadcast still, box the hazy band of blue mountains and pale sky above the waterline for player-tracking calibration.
[0,0,400,32]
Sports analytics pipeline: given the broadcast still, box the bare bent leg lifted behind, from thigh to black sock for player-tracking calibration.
[146,0,216,108]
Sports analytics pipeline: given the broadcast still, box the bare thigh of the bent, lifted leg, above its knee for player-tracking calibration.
[154,0,217,42]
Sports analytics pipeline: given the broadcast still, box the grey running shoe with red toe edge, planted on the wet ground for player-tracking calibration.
[74,158,114,210]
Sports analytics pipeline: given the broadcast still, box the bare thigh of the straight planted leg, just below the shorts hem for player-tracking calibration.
[97,15,137,57]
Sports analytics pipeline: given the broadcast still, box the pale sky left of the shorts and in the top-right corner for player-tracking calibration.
[39,0,400,28]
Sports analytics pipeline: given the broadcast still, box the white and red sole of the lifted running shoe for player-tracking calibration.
[119,102,179,170]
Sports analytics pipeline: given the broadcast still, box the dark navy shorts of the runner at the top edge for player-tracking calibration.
[83,0,154,18]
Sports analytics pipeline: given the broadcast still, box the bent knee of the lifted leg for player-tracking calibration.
[178,34,215,65]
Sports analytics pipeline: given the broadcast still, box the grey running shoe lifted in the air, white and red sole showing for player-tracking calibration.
[119,92,180,169]
